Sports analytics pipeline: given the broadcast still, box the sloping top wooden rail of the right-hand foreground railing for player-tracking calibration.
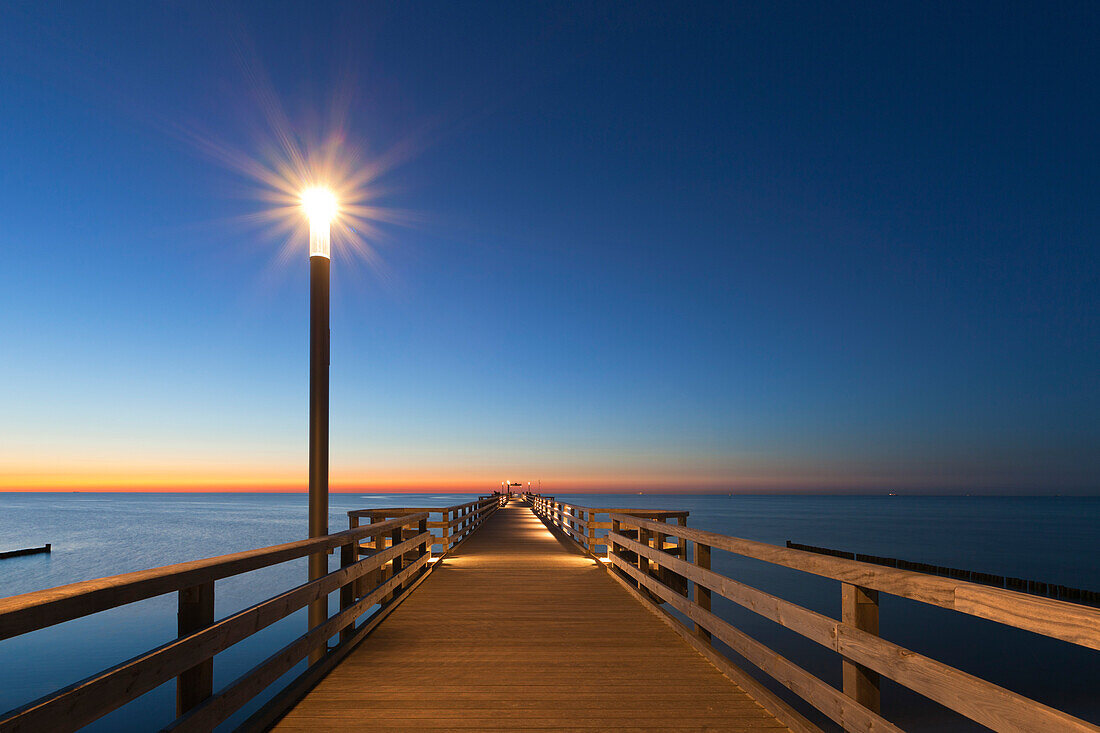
[612,514,1100,650]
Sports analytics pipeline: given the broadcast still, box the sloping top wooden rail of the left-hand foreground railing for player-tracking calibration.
[0,513,428,639]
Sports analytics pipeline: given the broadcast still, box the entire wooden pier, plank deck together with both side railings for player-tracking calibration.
[0,495,1100,733]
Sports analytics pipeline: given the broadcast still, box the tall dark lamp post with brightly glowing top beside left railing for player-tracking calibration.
[301,183,337,664]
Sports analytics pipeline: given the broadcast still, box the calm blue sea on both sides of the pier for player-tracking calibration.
[0,491,1100,733]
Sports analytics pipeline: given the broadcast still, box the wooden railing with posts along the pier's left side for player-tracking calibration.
[0,497,501,733]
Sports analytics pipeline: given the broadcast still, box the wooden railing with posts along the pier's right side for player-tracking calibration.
[585,510,1100,733]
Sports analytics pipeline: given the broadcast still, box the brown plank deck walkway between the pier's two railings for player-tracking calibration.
[275,503,787,733]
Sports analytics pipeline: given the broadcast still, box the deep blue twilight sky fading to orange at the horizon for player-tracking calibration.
[0,1,1100,494]
